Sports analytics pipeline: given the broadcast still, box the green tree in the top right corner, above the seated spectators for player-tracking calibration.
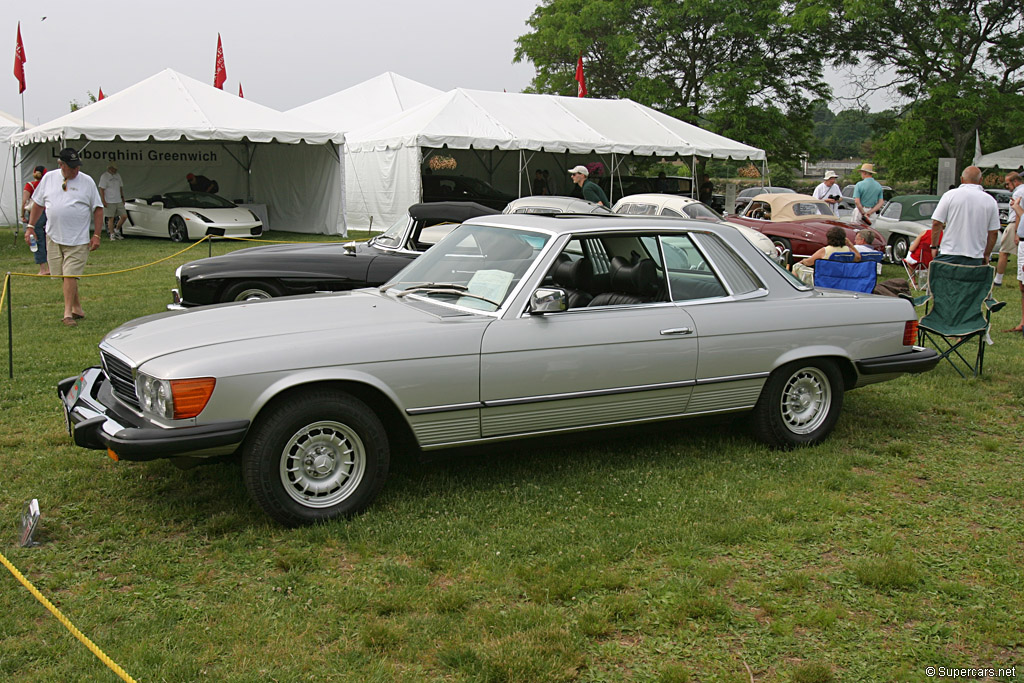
[844,0,1024,174]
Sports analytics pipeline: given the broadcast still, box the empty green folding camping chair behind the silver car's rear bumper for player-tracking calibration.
[905,261,1007,377]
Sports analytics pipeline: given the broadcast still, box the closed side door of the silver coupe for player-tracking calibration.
[480,236,698,438]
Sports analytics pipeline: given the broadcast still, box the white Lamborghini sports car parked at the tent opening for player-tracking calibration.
[122,191,263,242]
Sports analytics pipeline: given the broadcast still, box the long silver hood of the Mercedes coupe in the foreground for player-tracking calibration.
[101,289,493,377]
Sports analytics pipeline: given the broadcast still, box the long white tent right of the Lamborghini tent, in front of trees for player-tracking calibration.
[345,89,765,227]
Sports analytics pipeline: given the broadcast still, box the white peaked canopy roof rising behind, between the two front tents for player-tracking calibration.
[288,72,441,132]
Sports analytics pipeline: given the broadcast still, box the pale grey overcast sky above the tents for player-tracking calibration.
[6,0,890,127]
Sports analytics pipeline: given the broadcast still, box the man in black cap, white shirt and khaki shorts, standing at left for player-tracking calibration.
[25,147,103,327]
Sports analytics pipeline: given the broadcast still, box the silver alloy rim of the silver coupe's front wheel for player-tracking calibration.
[279,420,367,508]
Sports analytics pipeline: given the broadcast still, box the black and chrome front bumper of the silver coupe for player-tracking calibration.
[57,368,250,461]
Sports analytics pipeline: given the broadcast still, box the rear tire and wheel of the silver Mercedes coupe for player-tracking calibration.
[754,358,844,449]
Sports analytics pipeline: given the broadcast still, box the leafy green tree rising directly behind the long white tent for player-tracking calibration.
[515,0,830,162]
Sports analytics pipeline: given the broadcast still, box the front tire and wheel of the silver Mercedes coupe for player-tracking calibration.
[242,389,390,526]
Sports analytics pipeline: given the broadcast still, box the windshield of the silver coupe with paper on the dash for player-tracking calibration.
[381,225,550,311]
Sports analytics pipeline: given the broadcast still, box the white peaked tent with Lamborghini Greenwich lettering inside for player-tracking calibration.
[12,69,344,234]
